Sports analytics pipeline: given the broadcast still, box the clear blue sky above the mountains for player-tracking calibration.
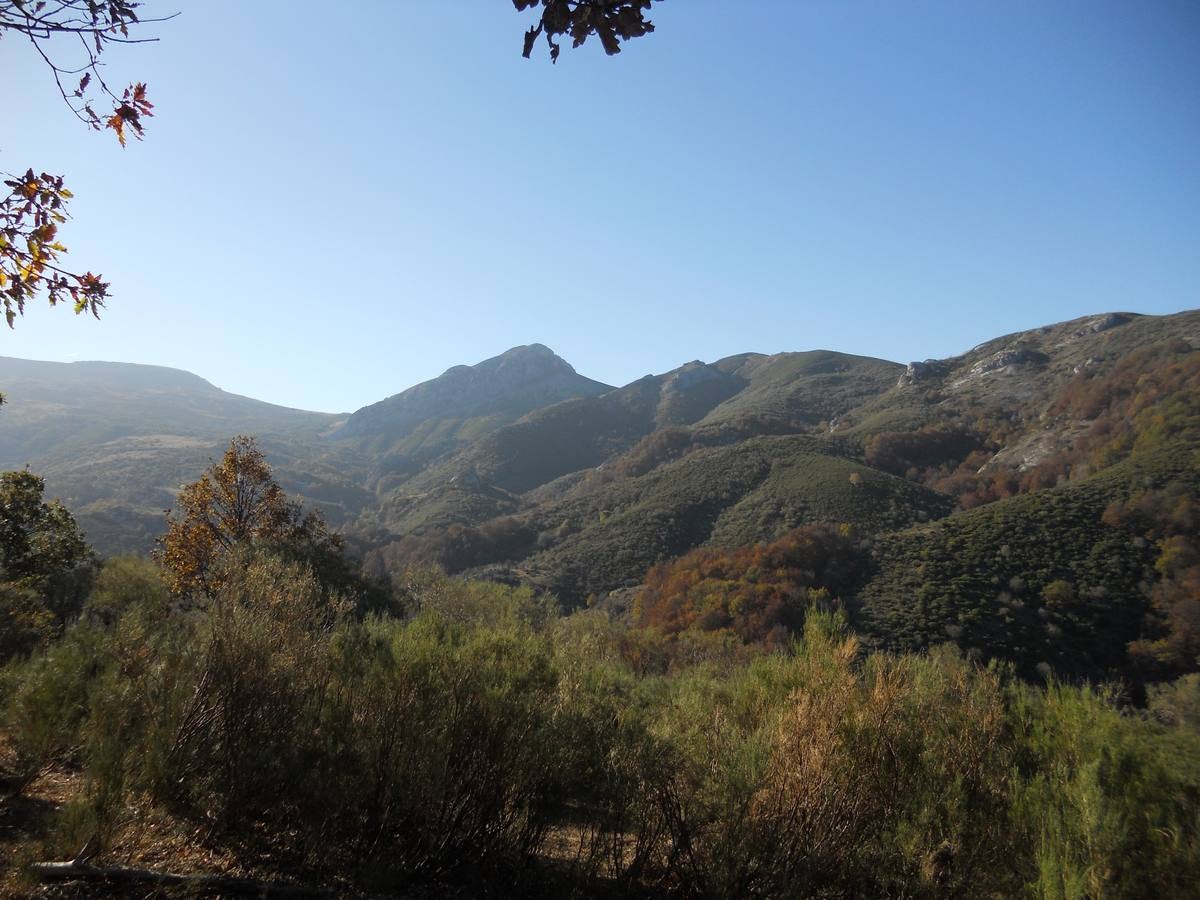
[0,0,1200,412]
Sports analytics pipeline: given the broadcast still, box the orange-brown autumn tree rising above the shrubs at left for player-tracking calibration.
[155,434,342,595]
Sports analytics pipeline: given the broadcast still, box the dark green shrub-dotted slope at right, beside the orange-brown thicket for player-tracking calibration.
[854,446,1196,677]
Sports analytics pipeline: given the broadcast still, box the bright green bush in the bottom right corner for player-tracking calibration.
[1009,684,1200,899]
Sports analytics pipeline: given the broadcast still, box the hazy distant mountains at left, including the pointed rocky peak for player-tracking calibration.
[0,344,611,553]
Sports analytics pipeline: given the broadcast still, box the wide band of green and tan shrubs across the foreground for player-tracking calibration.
[0,566,1200,898]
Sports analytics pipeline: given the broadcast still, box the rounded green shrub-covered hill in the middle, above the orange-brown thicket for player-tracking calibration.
[496,436,952,606]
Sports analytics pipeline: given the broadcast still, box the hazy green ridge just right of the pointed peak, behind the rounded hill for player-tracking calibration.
[369,350,902,532]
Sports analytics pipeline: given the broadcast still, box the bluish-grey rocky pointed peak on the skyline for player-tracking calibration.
[336,343,612,438]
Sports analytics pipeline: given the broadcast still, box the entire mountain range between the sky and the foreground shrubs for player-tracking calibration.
[0,311,1200,677]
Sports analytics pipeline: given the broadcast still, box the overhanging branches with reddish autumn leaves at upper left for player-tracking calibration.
[0,0,169,328]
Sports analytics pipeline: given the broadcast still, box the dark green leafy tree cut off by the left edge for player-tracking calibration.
[0,470,95,660]
